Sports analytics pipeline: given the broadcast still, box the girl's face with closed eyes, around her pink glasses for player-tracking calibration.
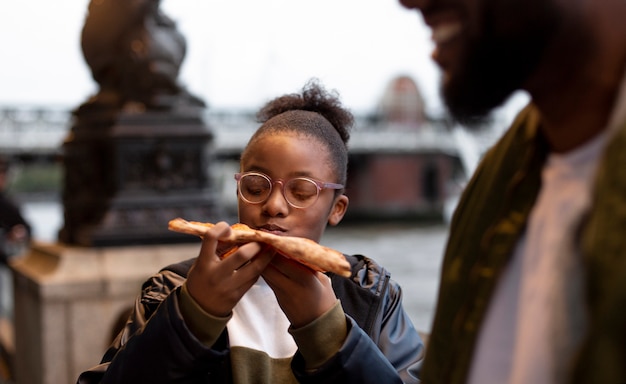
[238,133,348,242]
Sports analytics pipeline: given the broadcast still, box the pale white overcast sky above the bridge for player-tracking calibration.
[0,0,528,120]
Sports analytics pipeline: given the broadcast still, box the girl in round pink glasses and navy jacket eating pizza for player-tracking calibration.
[78,82,424,384]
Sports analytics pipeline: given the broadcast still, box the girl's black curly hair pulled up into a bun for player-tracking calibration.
[241,79,354,184]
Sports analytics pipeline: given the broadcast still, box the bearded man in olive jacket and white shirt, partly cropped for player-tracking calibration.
[400,0,626,384]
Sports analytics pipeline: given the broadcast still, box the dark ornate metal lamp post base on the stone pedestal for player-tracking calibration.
[59,0,219,246]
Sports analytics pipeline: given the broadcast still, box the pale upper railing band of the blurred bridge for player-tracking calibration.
[0,107,472,158]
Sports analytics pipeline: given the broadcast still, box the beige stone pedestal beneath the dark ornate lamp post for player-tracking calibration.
[11,241,200,384]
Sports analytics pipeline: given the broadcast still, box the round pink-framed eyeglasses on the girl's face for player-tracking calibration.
[235,172,343,208]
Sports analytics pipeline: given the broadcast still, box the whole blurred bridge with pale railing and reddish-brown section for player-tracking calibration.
[0,107,504,216]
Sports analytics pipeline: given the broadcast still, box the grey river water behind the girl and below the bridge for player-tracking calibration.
[22,201,448,332]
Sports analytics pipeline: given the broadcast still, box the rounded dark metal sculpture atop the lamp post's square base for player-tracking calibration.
[81,0,204,110]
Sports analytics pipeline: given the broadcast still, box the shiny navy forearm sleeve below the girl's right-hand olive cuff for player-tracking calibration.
[291,316,402,384]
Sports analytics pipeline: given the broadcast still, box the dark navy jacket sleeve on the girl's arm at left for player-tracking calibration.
[78,268,230,384]
